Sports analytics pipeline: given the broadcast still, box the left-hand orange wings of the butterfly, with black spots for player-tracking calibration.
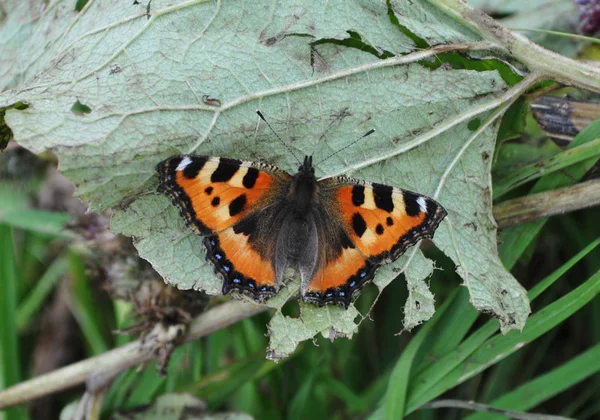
[157,155,291,299]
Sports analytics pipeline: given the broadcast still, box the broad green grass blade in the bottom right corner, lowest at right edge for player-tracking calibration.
[467,344,600,420]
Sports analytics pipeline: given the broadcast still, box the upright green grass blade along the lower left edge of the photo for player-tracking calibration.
[0,223,27,420]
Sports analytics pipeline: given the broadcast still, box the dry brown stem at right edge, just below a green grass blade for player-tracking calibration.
[494,179,600,228]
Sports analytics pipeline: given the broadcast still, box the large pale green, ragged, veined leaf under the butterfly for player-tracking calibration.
[0,0,529,358]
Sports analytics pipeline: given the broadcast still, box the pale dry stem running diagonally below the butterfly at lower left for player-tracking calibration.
[0,301,269,409]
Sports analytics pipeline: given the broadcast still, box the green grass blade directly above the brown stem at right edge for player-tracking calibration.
[494,138,600,199]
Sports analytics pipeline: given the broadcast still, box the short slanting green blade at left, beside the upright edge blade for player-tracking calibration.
[16,256,67,331]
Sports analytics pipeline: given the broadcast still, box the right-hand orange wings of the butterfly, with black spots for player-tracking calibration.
[303,177,447,306]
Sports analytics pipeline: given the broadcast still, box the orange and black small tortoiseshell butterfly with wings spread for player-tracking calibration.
[157,149,446,308]
